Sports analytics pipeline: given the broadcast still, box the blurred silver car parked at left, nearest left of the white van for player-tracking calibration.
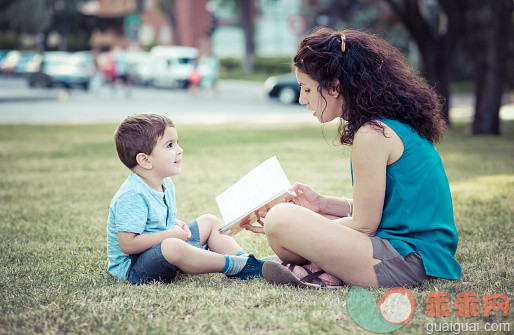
[27,51,95,90]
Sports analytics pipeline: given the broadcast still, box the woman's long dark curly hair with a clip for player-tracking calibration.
[293,27,445,145]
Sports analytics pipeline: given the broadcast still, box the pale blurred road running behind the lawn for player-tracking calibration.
[0,77,514,124]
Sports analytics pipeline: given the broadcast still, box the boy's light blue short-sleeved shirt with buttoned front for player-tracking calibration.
[107,173,177,280]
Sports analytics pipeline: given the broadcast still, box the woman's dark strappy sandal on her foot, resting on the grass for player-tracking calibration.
[262,262,344,289]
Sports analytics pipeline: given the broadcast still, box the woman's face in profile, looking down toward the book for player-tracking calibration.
[295,68,343,123]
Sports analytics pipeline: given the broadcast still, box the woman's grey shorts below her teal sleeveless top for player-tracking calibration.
[370,236,432,287]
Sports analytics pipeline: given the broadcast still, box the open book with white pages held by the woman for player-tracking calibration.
[216,156,296,235]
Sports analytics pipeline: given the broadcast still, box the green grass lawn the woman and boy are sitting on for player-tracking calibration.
[0,120,514,334]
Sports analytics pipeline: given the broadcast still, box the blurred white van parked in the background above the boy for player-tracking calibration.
[150,45,200,88]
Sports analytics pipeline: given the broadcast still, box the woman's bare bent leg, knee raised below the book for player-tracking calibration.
[264,203,381,287]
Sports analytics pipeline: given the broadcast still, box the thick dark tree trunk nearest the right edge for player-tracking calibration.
[473,0,513,135]
